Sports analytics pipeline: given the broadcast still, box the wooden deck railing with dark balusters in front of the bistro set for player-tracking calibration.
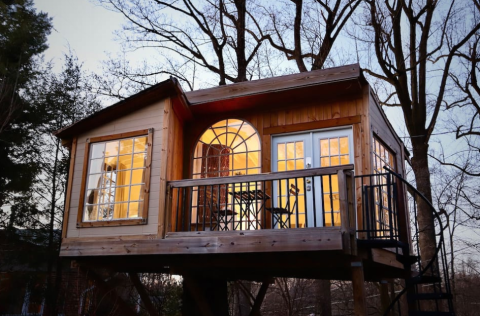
[167,165,356,232]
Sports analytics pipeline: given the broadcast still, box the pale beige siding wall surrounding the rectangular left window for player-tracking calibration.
[66,100,165,239]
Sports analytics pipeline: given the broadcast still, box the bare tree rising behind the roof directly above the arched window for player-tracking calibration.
[99,0,276,89]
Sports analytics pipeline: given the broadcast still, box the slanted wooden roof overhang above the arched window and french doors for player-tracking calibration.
[185,64,366,116]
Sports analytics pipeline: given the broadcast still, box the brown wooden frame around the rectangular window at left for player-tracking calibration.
[77,128,153,228]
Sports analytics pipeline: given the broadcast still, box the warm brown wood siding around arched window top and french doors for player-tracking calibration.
[184,95,368,178]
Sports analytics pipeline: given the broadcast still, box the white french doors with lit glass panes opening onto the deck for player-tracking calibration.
[272,128,354,228]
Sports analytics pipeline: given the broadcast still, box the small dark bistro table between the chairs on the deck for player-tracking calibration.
[228,190,270,230]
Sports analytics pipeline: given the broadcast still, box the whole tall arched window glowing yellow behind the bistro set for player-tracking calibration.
[192,119,262,230]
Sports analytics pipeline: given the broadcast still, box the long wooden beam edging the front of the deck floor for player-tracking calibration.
[60,227,351,257]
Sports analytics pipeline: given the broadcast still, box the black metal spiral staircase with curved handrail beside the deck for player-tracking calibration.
[357,169,455,316]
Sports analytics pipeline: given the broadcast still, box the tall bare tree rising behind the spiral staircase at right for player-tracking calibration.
[356,0,480,263]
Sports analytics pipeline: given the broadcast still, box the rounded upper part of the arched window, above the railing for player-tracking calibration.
[193,119,261,179]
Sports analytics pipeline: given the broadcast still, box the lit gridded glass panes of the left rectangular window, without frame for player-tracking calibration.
[83,136,148,222]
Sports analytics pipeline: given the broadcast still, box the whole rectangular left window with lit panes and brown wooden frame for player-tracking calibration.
[79,130,152,227]
